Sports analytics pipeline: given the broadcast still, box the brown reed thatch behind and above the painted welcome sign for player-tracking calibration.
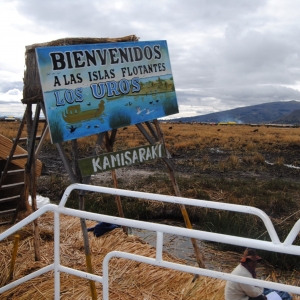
[22,35,138,104]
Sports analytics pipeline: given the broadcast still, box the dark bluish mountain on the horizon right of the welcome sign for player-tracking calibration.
[176,101,300,124]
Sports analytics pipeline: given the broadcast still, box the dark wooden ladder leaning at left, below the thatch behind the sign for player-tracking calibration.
[0,103,48,225]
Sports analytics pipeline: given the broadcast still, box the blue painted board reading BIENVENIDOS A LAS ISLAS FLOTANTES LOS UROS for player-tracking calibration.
[36,41,178,143]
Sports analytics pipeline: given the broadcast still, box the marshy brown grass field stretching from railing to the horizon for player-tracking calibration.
[0,122,300,269]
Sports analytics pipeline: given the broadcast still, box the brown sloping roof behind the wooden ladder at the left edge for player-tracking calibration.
[0,134,42,176]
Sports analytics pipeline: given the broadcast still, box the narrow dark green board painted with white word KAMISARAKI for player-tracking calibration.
[78,144,165,177]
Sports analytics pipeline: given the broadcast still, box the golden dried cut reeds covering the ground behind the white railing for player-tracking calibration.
[0,213,300,300]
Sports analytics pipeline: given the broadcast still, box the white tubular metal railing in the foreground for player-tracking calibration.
[0,184,300,300]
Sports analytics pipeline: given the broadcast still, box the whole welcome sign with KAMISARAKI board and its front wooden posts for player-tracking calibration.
[25,36,204,299]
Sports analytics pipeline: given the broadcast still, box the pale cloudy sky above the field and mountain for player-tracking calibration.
[0,0,300,117]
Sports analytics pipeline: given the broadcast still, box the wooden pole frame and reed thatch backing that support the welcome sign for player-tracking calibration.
[0,35,204,299]
